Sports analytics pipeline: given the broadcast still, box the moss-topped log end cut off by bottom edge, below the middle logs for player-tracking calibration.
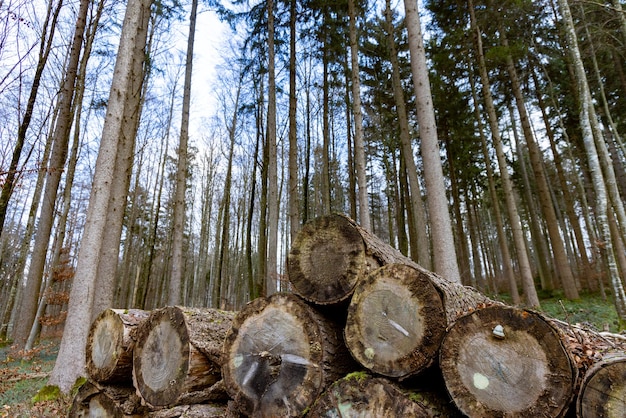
[307,372,440,418]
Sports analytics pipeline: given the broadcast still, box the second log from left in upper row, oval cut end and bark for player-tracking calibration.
[133,306,234,408]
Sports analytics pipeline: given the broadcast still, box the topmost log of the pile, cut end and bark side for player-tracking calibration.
[287,214,495,324]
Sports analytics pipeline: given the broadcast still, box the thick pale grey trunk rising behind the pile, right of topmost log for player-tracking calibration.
[404,0,461,283]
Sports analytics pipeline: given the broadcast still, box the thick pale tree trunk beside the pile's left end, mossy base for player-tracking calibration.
[49,0,151,393]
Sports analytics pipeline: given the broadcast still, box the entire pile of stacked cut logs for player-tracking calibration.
[70,215,626,418]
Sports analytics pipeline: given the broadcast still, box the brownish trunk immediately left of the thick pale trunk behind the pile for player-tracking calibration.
[385,0,431,269]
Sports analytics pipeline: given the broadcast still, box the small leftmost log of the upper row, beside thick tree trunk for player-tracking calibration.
[85,309,150,384]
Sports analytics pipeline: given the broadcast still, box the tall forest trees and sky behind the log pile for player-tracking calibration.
[0,0,626,390]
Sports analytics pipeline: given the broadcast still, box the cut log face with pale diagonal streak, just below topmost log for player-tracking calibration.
[344,264,447,378]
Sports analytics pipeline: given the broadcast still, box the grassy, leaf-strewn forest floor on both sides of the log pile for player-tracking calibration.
[0,295,619,418]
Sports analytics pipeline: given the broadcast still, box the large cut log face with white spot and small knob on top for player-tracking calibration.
[440,306,577,417]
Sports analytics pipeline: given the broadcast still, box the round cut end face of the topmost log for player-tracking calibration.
[287,215,367,305]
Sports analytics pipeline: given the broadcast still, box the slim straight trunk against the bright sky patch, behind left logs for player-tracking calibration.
[168,0,198,305]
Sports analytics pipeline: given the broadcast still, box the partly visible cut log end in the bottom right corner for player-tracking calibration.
[577,351,626,418]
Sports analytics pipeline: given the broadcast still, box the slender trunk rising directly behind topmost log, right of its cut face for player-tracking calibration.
[348,0,372,231]
